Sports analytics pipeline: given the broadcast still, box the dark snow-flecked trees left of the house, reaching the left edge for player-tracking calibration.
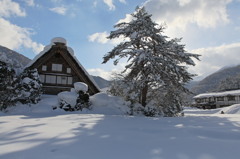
[0,61,42,110]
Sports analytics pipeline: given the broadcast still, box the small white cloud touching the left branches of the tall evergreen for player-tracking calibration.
[88,31,125,45]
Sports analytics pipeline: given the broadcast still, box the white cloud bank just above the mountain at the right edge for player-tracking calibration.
[189,43,240,76]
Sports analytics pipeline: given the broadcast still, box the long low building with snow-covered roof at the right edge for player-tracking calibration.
[193,90,240,109]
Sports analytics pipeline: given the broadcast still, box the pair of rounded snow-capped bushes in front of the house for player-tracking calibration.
[58,82,91,111]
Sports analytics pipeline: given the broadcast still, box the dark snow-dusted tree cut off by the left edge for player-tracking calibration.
[0,61,16,110]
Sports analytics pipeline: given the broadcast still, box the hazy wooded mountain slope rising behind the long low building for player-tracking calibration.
[190,65,240,94]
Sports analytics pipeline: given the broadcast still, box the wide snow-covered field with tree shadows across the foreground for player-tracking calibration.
[0,95,240,159]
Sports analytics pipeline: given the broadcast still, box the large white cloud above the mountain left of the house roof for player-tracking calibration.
[0,18,43,53]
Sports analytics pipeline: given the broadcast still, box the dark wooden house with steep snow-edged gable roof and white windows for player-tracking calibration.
[27,38,100,94]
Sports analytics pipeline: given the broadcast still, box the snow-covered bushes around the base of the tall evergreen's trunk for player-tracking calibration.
[108,75,186,117]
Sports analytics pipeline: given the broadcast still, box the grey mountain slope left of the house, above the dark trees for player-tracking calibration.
[0,45,31,68]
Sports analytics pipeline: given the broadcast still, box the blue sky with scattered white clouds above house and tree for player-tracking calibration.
[0,0,240,78]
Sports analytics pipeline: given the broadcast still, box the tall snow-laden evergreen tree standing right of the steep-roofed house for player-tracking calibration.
[103,7,199,115]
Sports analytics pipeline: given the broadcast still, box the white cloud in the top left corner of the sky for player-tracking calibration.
[0,0,26,18]
